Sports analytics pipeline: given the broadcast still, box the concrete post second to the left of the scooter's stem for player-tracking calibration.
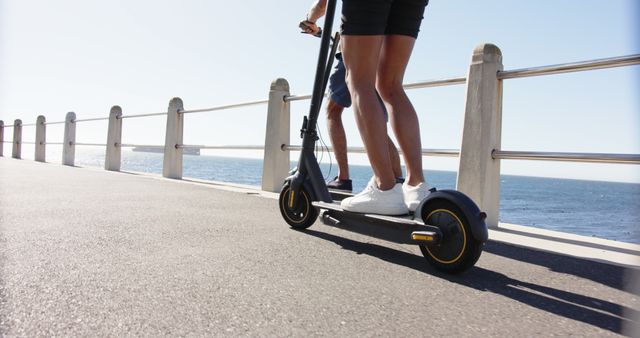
[162,97,184,179]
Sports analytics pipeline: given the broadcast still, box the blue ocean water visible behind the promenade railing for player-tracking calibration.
[76,151,640,244]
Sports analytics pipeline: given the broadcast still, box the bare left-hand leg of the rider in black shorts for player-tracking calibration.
[342,35,395,190]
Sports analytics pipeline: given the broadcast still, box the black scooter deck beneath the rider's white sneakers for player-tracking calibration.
[312,202,442,244]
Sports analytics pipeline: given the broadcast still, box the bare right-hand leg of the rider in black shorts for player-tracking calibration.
[376,35,424,186]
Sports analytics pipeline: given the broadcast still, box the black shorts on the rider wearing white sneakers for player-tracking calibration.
[341,0,429,38]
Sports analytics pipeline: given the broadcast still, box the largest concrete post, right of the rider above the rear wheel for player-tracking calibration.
[457,44,503,228]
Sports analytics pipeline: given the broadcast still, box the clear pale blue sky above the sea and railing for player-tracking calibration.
[0,0,640,182]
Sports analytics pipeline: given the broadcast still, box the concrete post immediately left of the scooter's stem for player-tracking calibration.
[262,79,291,192]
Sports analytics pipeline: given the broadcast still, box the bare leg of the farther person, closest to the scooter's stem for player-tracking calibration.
[327,98,349,180]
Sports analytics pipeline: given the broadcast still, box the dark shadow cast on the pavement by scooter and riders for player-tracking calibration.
[301,229,640,333]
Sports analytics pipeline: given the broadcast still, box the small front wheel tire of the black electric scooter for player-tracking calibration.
[278,183,319,229]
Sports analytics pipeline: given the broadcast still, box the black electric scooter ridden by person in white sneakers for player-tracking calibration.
[278,0,488,273]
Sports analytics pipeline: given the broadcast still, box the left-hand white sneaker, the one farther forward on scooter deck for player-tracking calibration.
[340,177,408,215]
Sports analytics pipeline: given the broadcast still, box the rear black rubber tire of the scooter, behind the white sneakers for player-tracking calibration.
[420,199,484,274]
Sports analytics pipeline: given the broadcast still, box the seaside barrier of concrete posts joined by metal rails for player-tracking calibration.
[0,44,640,228]
